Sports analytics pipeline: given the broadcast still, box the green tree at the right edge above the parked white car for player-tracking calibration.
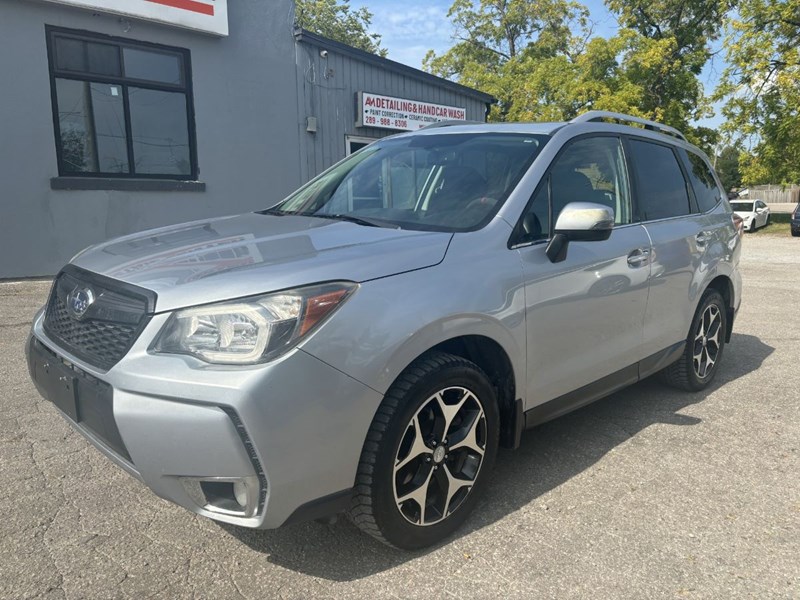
[717,0,800,185]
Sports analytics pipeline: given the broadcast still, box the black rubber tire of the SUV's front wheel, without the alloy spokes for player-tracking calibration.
[350,352,500,550]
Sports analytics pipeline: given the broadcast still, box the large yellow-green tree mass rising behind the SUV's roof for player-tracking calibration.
[424,0,732,145]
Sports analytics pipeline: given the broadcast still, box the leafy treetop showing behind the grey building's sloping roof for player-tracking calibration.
[295,0,387,56]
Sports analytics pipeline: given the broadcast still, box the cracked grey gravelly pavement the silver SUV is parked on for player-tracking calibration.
[0,235,800,600]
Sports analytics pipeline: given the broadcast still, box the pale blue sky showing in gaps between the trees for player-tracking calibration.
[350,0,723,127]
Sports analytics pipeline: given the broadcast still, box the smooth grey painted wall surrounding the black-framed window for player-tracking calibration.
[0,0,301,278]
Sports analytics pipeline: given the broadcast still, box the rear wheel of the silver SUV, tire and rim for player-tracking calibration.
[660,289,728,392]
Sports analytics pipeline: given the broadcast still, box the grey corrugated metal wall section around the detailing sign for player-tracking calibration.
[296,37,487,179]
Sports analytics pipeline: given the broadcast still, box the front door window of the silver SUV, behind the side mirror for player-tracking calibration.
[519,137,631,242]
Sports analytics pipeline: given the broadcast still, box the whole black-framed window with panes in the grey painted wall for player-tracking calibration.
[47,28,197,180]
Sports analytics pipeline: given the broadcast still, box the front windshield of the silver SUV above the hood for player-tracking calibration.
[265,133,549,232]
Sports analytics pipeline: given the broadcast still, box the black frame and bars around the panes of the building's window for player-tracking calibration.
[45,25,199,181]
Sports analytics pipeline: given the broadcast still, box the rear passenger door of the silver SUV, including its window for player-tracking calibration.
[627,138,714,358]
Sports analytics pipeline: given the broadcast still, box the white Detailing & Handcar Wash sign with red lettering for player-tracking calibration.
[356,92,467,131]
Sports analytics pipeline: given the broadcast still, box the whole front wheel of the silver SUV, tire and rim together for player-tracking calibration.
[350,352,500,550]
